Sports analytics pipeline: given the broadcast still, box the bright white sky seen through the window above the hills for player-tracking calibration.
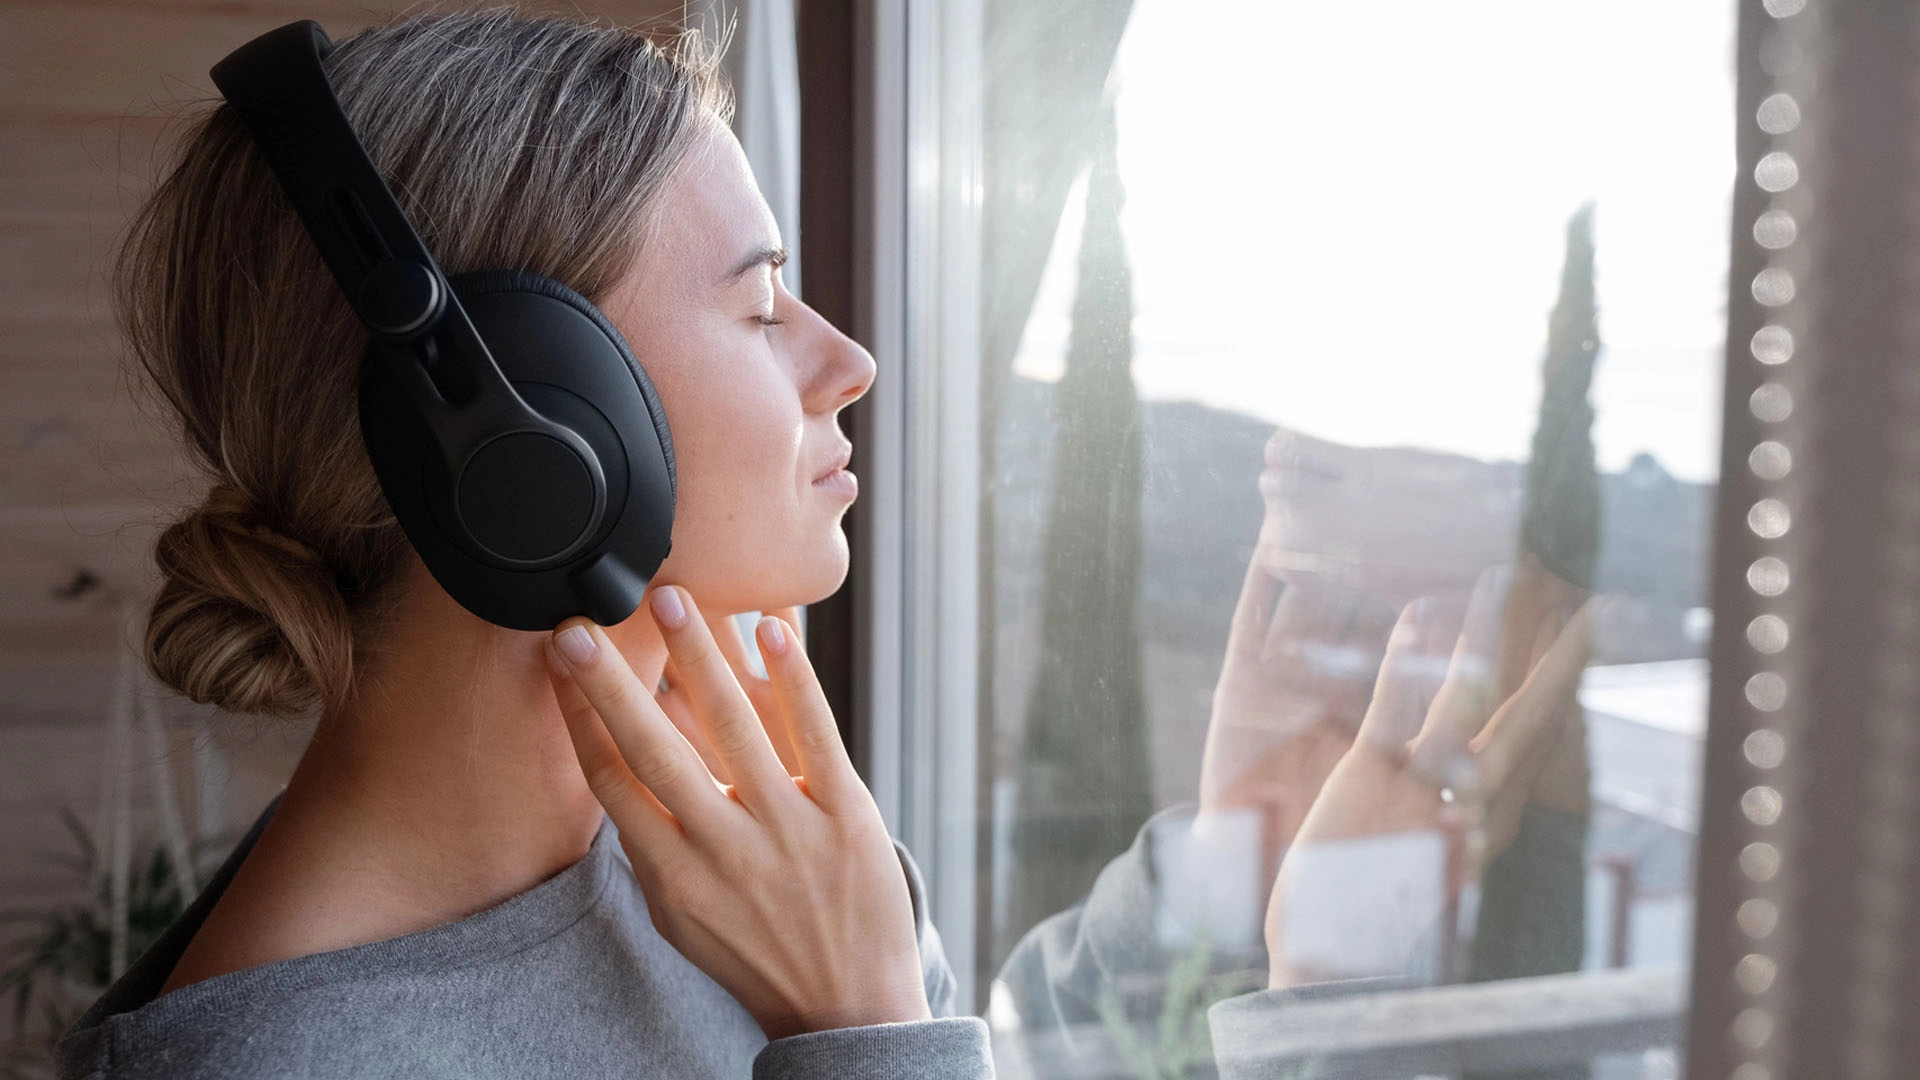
[1014,0,1736,480]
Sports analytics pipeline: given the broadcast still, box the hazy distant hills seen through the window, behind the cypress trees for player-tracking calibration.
[983,377,1713,801]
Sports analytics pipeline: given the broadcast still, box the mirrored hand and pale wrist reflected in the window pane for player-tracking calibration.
[1267,573,1596,986]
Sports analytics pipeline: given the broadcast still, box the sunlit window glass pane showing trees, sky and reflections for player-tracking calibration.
[956,0,1735,1076]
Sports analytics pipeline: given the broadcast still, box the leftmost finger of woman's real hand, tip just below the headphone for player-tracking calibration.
[547,619,728,838]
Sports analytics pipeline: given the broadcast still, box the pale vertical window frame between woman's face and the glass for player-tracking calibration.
[852,0,987,1011]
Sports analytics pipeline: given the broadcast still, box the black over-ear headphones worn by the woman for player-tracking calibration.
[213,21,674,630]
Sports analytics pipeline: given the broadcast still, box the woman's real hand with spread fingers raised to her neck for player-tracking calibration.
[549,584,931,1040]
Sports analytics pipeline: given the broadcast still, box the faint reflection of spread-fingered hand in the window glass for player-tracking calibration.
[1267,573,1594,986]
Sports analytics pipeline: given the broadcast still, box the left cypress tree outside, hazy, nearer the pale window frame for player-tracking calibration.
[1006,100,1154,957]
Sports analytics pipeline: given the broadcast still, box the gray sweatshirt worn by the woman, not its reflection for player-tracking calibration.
[58,780,993,1080]
